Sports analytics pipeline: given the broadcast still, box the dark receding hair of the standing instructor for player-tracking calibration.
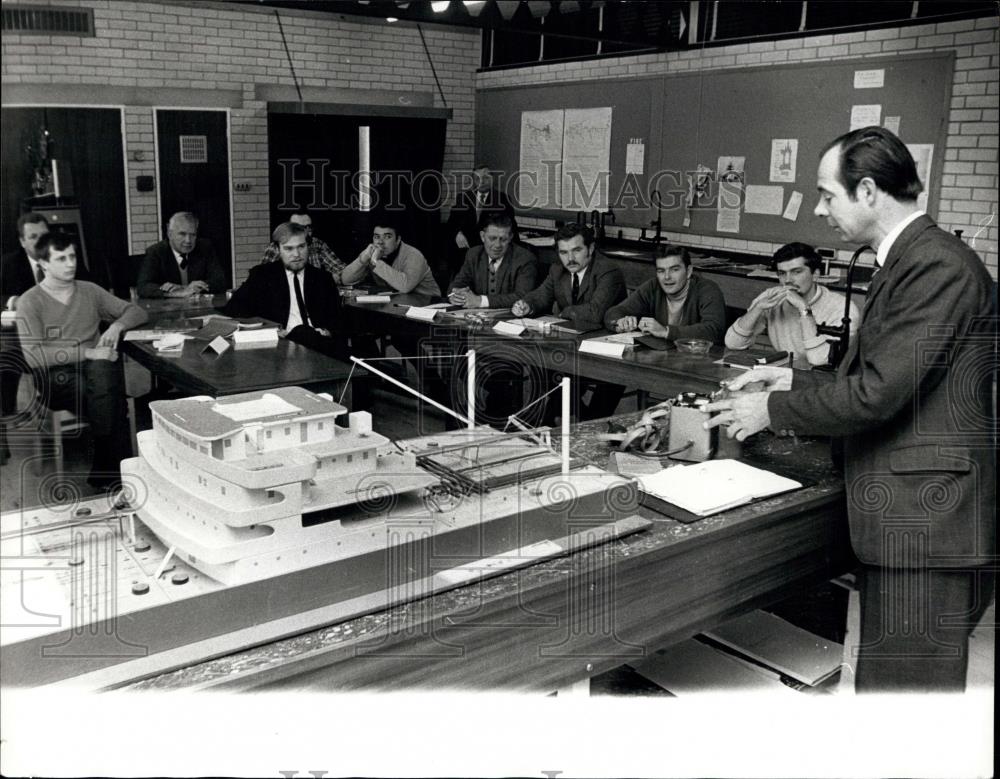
[823,127,924,202]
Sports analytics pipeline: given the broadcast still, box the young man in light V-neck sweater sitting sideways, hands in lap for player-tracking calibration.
[17,233,147,489]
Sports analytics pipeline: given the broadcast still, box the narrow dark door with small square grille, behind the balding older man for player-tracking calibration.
[156,109,233,284]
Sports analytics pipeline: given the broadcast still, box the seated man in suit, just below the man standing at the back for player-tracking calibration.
[448,213,538,308]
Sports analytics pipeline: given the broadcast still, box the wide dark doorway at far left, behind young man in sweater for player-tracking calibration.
[0,107,128,296]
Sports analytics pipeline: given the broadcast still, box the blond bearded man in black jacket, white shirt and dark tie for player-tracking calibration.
[221,222,347,359]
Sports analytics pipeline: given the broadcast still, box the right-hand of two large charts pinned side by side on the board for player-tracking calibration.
[562,106,611,211]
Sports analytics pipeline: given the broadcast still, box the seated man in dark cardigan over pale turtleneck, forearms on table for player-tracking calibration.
[604,246,726,344]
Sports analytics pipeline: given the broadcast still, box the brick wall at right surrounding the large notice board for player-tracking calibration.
[476,17,1000,279]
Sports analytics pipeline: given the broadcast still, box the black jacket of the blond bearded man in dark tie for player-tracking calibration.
[221,262,343,333]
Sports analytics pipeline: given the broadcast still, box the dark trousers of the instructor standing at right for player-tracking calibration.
[855,566,994,693]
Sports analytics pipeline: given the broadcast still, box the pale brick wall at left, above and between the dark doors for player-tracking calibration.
[2,0,480,280]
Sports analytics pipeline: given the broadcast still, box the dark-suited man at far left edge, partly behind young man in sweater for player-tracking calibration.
[0,212,49,462]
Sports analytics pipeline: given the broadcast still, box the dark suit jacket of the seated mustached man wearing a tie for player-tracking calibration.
[524,252,626,329]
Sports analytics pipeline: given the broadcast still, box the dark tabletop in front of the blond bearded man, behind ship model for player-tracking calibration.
[122,296,367,397]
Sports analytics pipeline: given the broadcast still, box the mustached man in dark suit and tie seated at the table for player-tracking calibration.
[511,224,625,425]
